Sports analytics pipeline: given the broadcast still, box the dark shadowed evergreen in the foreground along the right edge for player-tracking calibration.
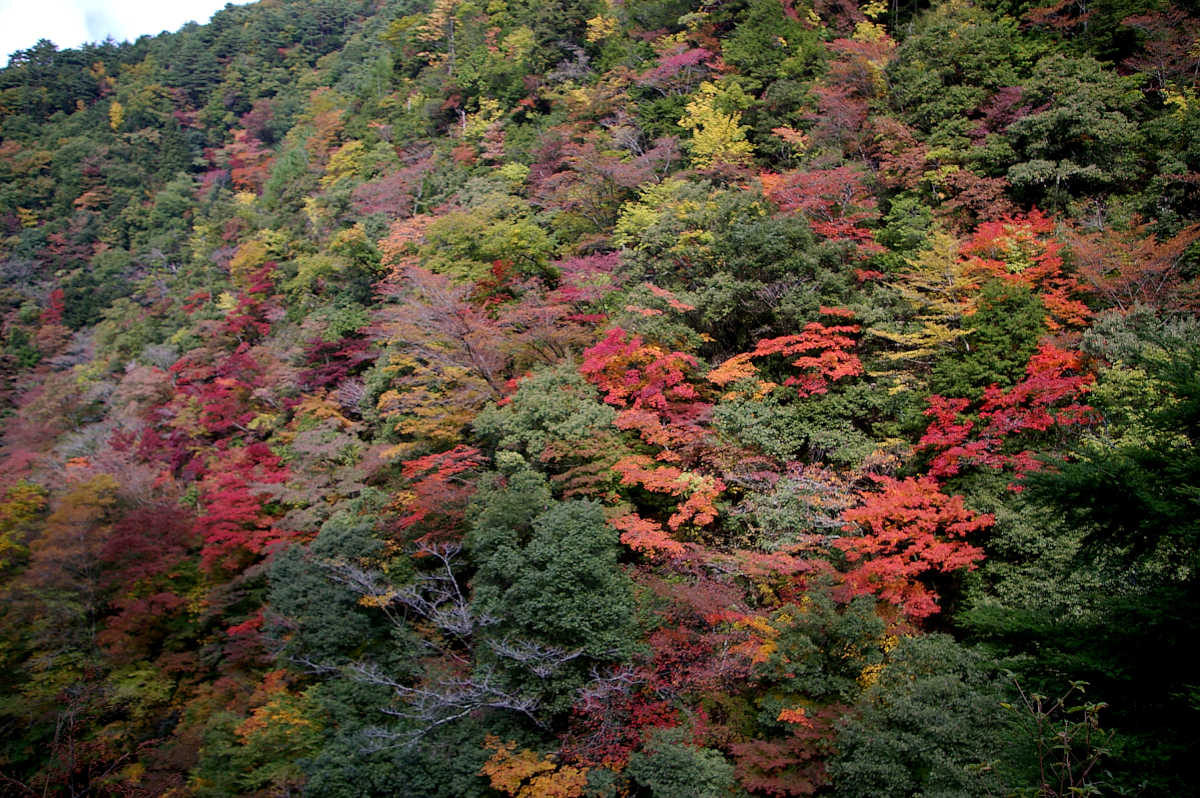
[962,310,1200,794]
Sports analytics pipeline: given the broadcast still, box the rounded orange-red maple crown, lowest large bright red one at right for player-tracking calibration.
[834,476,994,620]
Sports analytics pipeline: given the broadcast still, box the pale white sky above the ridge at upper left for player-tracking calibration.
[0,0,258,65]
